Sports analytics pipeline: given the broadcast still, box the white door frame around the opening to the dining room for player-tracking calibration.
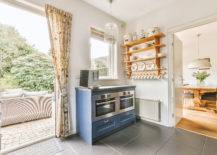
[166,13,217,127]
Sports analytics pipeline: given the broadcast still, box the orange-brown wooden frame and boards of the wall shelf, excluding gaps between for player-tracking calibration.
[122,32,166,79]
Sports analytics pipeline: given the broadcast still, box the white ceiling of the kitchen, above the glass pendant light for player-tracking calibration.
[83,0,177,22]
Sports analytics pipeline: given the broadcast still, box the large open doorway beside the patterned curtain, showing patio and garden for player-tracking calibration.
[0,2,55,152]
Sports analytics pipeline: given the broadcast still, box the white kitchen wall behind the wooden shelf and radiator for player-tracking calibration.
[127,0,217,126]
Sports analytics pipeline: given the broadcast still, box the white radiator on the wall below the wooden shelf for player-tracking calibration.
[135,98,161,122]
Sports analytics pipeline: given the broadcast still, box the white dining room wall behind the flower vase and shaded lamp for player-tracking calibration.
[183,32,217,85]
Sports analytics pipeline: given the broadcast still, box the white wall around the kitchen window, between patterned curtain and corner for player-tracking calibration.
[22,0,124,132]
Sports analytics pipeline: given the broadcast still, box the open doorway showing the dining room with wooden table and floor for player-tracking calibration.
[173,22,217,138]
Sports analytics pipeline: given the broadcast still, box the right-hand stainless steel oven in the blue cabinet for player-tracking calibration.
[119,91,135,112]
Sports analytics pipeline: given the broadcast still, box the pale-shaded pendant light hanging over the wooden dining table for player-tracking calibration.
[188,34,211,70]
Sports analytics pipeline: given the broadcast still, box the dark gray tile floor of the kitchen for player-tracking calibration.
[6,122,217,155]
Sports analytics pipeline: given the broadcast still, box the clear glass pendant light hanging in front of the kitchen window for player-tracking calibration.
[105,0,118,43]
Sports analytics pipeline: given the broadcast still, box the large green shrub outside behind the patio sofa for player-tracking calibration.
[0,24,54,91]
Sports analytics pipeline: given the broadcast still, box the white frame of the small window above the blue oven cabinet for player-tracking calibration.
[90,27,117,80]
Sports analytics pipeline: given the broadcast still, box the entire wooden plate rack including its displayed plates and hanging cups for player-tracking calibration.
[123,32,166,79]
